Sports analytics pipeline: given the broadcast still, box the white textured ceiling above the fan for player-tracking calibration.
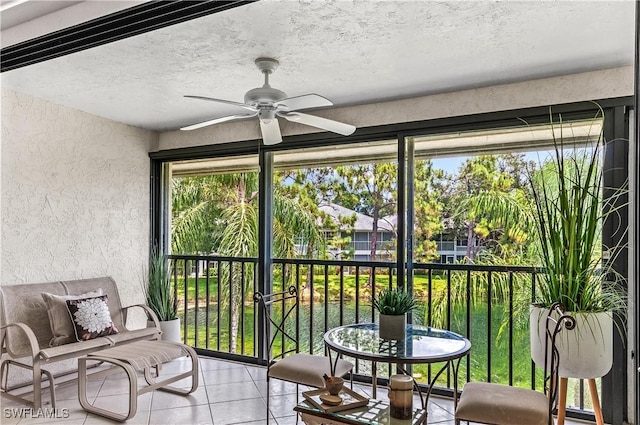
[2,0,634,131]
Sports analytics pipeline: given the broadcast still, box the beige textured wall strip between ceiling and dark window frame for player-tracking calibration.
[158,66,633,150]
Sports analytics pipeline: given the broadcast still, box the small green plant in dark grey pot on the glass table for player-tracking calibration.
[373,288,416,339]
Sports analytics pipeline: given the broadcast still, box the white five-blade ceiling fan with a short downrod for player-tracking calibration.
[180,58,356,145]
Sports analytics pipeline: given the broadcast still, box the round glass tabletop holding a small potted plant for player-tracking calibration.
[324,323,471,363]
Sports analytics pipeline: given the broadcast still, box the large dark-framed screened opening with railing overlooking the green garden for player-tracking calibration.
[151,100,630,420]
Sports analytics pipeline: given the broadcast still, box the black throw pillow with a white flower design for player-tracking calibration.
[67,295,118,341]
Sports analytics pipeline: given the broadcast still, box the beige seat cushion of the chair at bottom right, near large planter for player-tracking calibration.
[456,382,549,425]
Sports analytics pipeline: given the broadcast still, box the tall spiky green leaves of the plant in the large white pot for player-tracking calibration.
[530,111,626,312]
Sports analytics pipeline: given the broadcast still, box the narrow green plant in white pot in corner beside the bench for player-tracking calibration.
[144,248,181,342]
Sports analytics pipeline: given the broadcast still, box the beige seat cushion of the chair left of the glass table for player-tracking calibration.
[269,353,353,388]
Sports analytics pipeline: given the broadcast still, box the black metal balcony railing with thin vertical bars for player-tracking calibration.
[169,255,590,416]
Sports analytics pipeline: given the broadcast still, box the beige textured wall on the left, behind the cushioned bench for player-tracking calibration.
[0,90,156,305]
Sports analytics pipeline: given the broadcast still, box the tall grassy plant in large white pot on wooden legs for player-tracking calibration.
[529,110,626,385]
